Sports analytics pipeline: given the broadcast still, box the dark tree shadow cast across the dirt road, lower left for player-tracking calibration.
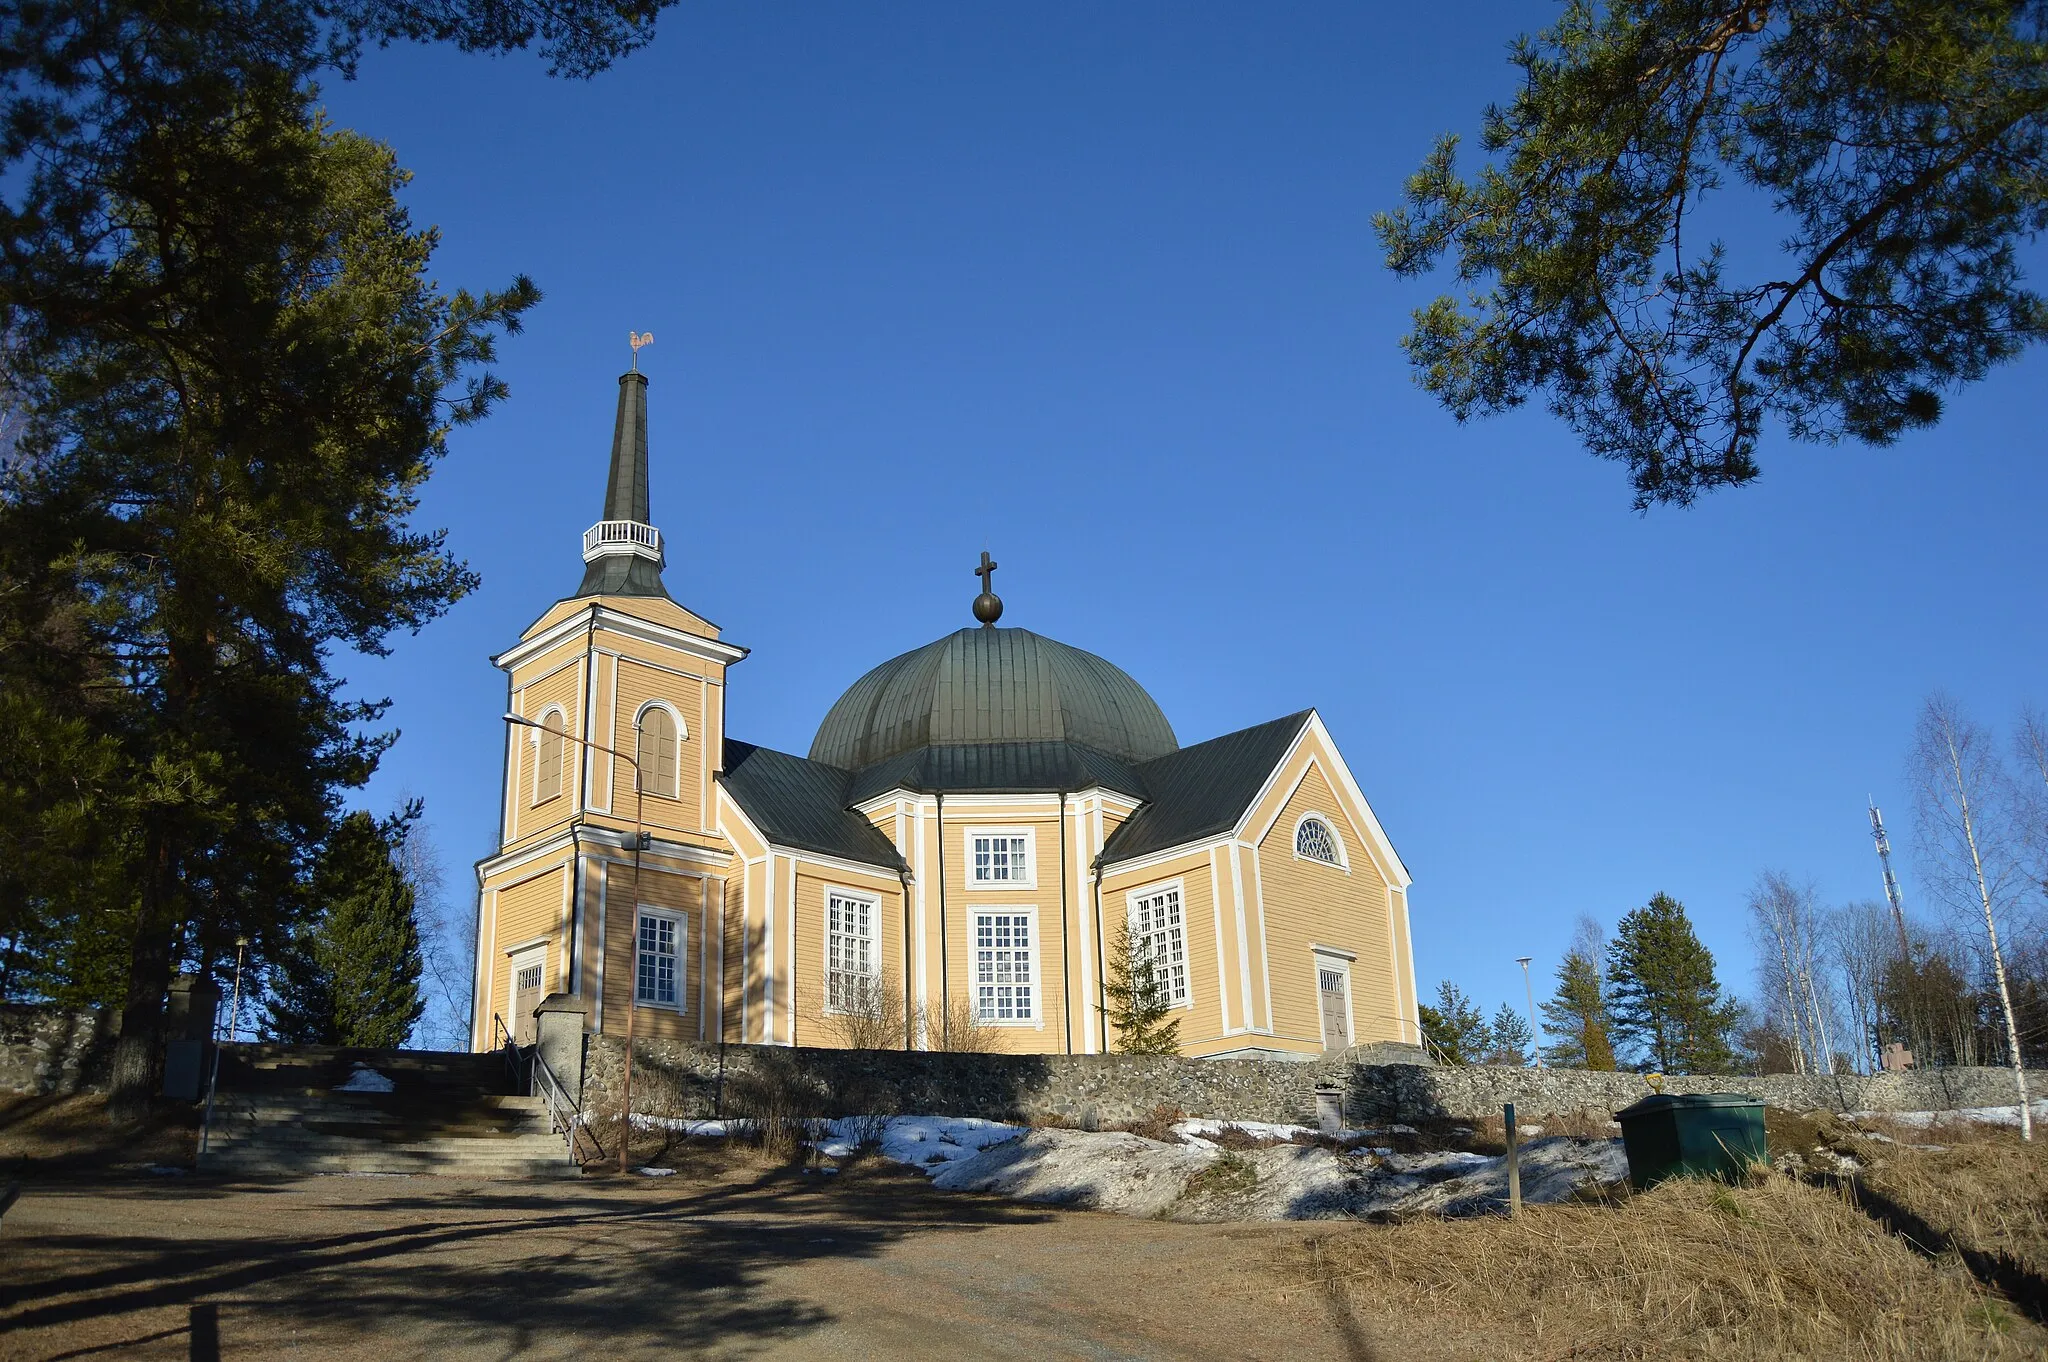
[0,1169,1047,1356]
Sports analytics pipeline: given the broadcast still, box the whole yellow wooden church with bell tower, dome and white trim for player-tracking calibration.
[473,373,1421,1059]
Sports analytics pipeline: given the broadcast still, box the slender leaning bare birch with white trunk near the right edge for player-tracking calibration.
[1911,694,2034,1141]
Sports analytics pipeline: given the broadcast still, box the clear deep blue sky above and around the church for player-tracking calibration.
[315,4,2048,1008]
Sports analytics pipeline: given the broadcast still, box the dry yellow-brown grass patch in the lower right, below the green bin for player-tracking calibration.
[1282,1178,2048,1362]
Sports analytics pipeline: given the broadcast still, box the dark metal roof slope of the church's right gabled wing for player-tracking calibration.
[1102,709,1315,864]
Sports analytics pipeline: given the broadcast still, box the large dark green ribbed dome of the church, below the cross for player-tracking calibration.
[811,629,1180,770]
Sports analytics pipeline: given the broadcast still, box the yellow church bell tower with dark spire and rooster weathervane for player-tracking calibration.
[471,356,745,1049]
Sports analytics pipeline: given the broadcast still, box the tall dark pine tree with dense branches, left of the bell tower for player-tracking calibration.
[0,0,664,1112]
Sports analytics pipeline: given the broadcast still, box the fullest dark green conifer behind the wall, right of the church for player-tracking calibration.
[1608,893,1737,1073]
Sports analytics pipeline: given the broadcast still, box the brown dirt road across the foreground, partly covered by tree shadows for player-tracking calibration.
[0,1167,1368,1362]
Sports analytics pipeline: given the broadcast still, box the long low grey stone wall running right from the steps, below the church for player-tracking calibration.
[584,1036,2048,1126]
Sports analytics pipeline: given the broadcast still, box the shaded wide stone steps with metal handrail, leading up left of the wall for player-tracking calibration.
[199,1045,580,1178]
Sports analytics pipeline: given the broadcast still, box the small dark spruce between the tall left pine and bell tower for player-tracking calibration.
[270,813,426,1049]
